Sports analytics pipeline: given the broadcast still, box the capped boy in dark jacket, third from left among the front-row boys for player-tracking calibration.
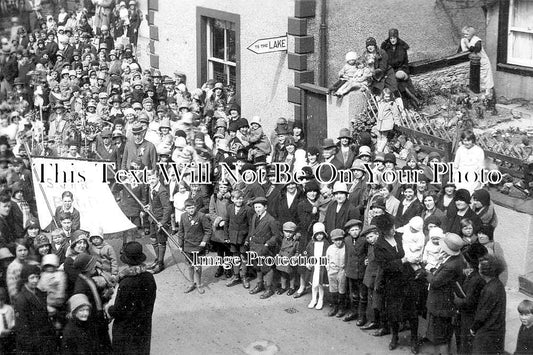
[245,197,281,299]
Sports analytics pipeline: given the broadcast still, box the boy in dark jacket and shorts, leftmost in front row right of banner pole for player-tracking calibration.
[178,198,212,294]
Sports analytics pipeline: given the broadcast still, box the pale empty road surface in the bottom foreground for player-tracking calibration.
[102,234,527,355]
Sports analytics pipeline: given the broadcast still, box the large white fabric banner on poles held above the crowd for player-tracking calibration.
[32,157,135,234]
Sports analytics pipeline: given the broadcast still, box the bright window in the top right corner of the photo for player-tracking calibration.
[507,0,533,67]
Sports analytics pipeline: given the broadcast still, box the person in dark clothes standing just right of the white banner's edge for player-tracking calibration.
[148,171,172,274]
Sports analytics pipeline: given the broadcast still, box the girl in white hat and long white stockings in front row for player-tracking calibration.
[304,222,329,309]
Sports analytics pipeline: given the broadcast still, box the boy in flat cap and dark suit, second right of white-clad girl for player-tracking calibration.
[337,219,368,326]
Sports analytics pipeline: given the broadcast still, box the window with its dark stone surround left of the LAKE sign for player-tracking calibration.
[196,6,241,104]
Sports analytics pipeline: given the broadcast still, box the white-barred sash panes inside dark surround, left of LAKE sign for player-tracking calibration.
[206,18,237,87]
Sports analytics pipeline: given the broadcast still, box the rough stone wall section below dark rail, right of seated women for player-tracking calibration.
[411,62,470,89]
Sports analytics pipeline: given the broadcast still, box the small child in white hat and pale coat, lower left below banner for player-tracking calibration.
[37,254,67,316]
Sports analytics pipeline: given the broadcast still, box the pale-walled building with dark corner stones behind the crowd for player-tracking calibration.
[134,0,485,131]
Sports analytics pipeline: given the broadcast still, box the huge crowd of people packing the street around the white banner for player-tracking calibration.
[0,1,533,354]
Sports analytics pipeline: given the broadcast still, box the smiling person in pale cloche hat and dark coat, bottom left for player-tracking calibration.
[61,293,100,354]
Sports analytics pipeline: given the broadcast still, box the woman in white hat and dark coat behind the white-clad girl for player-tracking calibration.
[324,182,360,235]
